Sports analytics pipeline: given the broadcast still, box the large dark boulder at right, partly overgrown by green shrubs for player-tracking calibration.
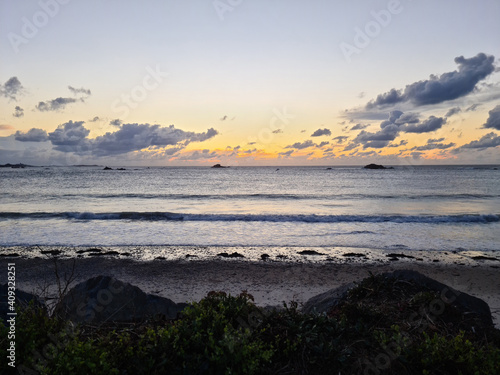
[302,270,493,327]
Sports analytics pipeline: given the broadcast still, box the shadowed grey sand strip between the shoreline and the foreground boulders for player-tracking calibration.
[0,257,500,328]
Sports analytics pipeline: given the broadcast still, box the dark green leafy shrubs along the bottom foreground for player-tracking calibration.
[0,277,500,375]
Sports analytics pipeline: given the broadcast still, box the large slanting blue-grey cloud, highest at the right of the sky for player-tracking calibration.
[366,53,495,109]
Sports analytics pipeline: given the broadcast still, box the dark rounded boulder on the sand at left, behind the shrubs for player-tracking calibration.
[55,276,187,323]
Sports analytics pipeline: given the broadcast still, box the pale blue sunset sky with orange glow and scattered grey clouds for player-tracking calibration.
[0,0,500,166]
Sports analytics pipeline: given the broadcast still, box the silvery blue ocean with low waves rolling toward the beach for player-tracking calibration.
[0,166,500,260]
